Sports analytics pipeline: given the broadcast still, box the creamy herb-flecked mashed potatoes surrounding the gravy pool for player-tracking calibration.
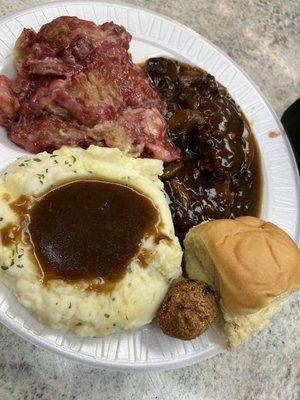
[0,146,182,337]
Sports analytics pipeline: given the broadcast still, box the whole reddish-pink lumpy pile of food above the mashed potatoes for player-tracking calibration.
[0,17,179,162]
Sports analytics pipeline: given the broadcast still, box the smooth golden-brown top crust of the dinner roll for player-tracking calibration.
[185,217,300,314]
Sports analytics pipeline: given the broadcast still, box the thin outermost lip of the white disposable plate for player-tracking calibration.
[0,0,300,371]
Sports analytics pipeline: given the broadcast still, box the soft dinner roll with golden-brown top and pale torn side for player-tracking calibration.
[184,217,300,349]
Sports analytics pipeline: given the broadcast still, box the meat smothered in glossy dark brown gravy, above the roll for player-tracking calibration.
[143,57,262,241]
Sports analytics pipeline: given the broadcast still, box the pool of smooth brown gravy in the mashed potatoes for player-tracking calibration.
[28,180,159,283]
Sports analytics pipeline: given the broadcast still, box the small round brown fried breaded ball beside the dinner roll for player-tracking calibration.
[156,279,218,340]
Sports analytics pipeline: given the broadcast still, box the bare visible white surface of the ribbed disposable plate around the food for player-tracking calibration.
[0,1,300,369]
